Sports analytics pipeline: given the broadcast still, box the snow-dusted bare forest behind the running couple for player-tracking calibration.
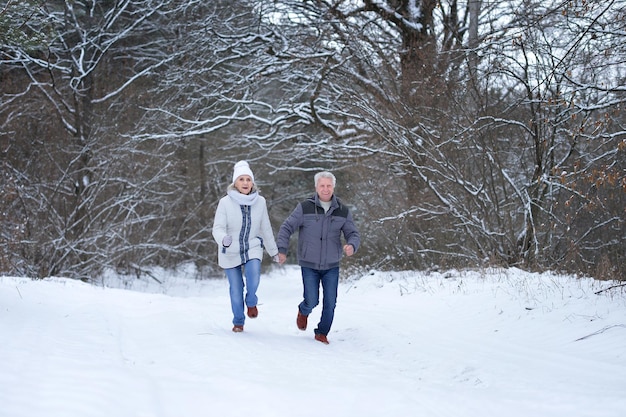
[0,0,626,280]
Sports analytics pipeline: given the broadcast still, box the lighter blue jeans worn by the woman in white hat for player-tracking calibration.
[225,259,261,326]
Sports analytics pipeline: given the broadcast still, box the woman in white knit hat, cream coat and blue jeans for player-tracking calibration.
[213,161,278,333]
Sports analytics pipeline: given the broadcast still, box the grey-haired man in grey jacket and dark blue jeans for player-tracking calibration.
[277,171,361,344]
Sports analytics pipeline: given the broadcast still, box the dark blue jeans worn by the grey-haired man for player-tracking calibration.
[298,267,339,335]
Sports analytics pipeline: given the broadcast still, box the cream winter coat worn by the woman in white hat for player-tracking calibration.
[213,189,278,269]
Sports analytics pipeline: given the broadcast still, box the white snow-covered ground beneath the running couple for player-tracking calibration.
[0,265,626,417]
